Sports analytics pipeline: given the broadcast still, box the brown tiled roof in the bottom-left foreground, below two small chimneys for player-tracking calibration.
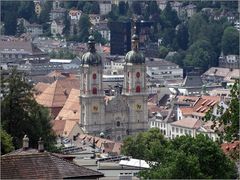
[1,152,104,179]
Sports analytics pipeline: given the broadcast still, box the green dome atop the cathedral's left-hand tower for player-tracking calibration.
[82,52,102,65]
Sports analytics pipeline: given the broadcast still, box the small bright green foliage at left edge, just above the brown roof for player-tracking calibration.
[0,127,14,155]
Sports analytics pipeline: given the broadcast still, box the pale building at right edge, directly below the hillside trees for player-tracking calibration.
[219,54,240,69]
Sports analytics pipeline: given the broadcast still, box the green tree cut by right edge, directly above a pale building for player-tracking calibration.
[222,27,239,55]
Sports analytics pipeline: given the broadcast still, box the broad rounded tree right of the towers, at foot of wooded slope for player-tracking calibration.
[184,40,216,70]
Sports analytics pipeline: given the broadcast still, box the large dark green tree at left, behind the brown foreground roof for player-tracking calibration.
[1,70,55,150]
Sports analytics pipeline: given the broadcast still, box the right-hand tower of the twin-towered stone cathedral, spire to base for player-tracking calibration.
[123,27,148,135]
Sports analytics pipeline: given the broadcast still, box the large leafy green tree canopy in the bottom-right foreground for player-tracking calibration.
[122,128,237,179]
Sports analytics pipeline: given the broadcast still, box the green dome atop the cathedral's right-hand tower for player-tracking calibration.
[125,50,145,64]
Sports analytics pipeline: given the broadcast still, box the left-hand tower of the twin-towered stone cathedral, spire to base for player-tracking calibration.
[80,29,105,135]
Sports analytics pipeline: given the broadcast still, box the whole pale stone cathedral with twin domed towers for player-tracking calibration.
[80,27,148,141]
